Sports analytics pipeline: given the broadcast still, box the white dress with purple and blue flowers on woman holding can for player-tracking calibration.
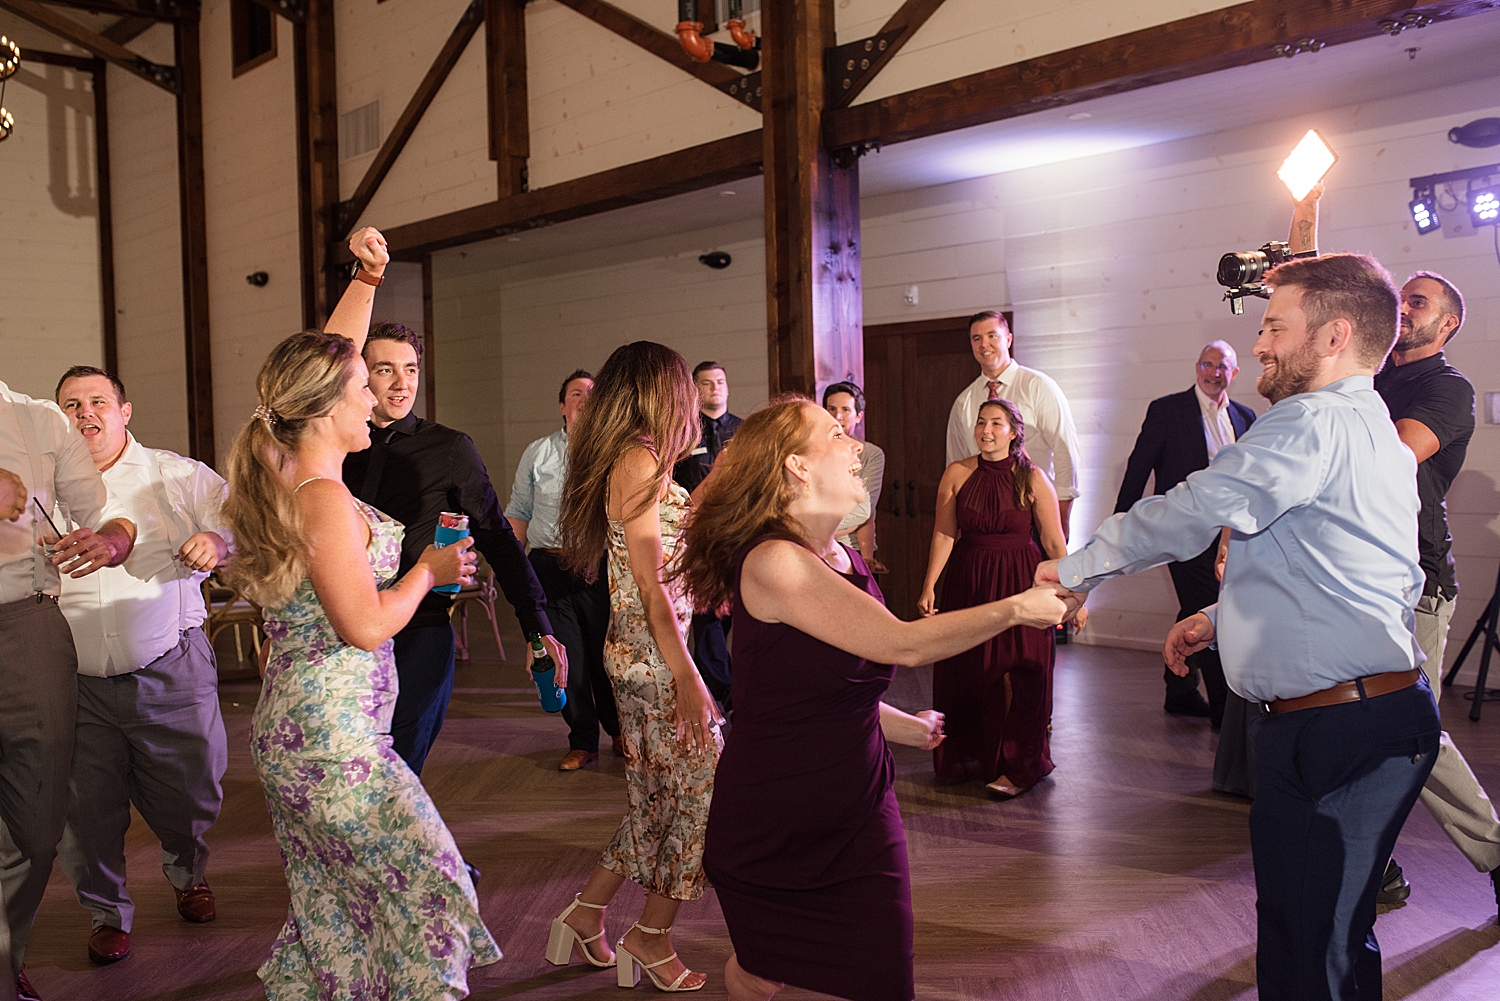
[251,501,501,1001]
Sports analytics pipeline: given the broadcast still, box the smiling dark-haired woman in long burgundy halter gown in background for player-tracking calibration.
[917,399,1086,798]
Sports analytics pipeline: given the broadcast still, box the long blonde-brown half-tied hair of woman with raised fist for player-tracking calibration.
[221,332,356,608]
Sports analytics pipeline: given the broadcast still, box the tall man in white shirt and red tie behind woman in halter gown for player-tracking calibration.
[948,309,1079,537]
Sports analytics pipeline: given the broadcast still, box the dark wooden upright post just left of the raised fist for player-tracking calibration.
[293,0,344,330]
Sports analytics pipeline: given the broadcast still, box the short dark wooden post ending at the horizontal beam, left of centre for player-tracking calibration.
[485,0,531,198]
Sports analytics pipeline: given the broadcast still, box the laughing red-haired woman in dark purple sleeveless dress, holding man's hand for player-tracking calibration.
[675,399,1076,1001]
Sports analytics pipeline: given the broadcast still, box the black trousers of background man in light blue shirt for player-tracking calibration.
[531,549,620,753]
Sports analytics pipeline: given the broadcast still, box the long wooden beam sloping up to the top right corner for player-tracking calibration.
[828,0,1500,147]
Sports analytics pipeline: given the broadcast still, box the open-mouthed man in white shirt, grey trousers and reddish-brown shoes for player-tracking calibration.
[57,366,230,963]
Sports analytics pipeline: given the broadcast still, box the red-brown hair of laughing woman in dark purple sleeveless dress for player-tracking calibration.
[671,396,818,611]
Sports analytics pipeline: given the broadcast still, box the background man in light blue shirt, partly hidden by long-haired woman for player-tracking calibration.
[506,369,620,771]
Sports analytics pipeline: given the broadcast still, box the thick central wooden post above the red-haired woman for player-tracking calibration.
[761,0,864,396]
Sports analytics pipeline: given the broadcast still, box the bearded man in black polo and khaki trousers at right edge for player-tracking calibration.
[1376,272,1500,905]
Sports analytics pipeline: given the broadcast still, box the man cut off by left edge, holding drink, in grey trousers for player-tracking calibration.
[0,383,135,998]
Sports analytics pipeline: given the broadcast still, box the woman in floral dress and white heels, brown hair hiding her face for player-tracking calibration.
[548,341,723,990]
